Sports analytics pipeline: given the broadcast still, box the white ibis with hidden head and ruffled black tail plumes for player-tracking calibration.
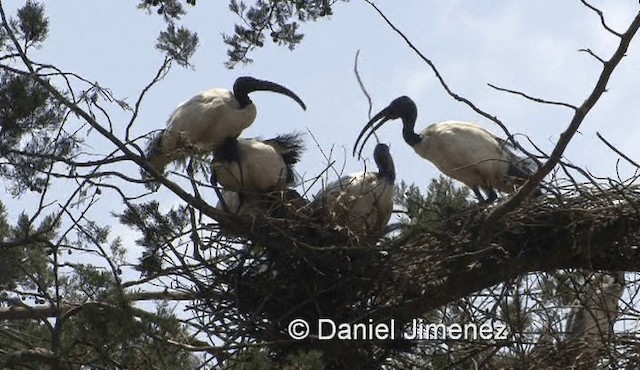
[211,133,304,193]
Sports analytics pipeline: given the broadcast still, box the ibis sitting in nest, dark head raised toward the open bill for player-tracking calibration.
[313,144,396,238]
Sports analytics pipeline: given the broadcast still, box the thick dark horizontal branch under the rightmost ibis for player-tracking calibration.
[373,189,640,318]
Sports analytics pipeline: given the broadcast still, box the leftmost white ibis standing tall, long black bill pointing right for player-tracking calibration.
[147,77,306,172]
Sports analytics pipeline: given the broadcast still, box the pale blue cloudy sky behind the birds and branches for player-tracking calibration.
[3,0,640,290]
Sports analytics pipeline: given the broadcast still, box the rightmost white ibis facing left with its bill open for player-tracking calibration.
[353,96,539,204]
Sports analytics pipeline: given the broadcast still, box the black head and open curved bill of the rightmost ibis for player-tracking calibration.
[353,96,418,157]
